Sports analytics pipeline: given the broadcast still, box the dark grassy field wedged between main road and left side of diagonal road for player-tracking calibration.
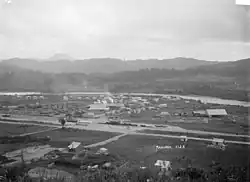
[32,129,119,148]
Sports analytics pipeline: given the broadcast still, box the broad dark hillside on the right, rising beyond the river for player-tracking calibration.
[96,59,250,101]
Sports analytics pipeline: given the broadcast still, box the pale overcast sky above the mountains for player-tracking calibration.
[0,0,250,61]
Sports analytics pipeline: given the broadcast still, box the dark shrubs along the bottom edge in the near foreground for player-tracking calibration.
[0,166,249,182]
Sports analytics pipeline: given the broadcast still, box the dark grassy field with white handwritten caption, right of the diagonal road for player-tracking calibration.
[98,136,250,169]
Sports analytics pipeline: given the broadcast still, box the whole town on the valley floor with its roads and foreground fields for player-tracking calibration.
[0,93,250,181]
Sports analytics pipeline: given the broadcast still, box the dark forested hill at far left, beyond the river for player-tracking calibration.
[0,64,87,92]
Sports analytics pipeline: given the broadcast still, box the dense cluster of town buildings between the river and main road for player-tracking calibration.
[0,94,231,129]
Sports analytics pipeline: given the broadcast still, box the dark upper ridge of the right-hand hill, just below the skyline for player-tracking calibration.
[102,59,250,81]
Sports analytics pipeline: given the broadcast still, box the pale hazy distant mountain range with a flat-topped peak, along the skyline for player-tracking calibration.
[2,54,218,74]
